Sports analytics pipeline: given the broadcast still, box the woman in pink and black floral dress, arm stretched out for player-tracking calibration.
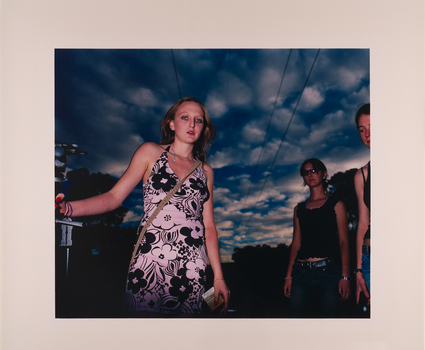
[56,97,230,317]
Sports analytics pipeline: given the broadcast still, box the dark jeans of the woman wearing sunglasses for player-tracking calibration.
[289,263,342,318]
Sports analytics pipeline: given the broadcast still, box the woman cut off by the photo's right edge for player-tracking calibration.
[354,103,371,304]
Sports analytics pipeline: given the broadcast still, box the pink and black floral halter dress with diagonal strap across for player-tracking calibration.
[126,147,209,315]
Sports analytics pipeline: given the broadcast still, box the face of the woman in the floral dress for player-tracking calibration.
[170,102,204,143]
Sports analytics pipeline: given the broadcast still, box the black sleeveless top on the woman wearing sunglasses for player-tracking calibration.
[296,197,341,261]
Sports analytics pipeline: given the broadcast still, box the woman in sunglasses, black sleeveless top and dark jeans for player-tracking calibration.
[283,158,350,318]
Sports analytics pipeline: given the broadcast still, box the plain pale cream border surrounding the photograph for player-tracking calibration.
[0,0,425,350]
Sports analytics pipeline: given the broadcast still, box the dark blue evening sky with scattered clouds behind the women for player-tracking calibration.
[55,49,370,261]
